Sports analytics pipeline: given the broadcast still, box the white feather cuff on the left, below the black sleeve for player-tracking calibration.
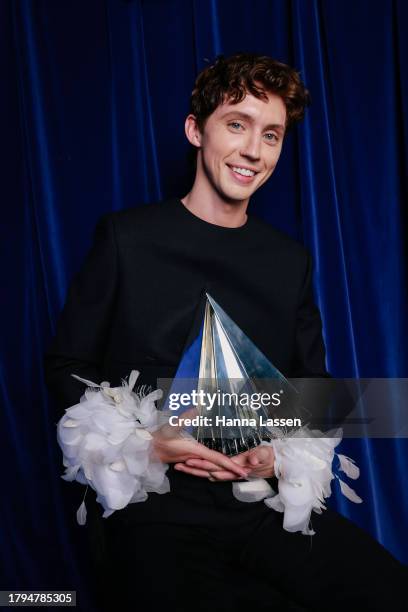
[57,371,170,525]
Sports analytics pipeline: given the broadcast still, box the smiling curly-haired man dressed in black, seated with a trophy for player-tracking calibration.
[46,54,403,611]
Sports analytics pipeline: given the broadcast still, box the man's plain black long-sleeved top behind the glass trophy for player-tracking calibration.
[46,198,326,416]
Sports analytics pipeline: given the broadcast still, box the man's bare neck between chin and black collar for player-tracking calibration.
[181,183,249,227]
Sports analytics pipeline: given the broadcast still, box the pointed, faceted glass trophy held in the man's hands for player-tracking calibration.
[164,293,310,456]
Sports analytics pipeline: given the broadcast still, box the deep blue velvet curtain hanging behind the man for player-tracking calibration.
[0,0,408,609]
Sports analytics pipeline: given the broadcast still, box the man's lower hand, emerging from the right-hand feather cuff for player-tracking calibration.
[174,445,275,480]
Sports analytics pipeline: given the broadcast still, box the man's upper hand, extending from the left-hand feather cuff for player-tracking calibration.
[152,418,248,479]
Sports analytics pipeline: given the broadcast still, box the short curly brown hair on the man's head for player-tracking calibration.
[190,53,310,131]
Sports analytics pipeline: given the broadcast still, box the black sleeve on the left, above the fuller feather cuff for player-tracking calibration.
[45,215,118,413]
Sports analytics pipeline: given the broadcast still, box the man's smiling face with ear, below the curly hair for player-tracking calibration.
[186,93,286,204]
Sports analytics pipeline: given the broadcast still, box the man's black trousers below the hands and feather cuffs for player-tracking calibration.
[89,468,408,612]
